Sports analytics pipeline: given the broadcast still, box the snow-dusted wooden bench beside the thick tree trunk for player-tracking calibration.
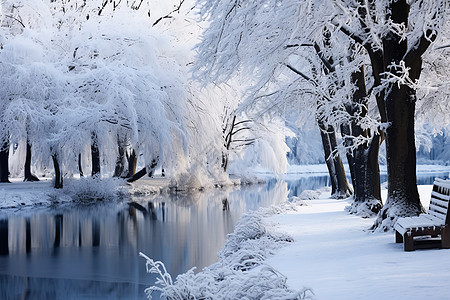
[394,178,450,251]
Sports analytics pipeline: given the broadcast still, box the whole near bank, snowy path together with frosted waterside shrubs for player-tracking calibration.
[145,185,450,299]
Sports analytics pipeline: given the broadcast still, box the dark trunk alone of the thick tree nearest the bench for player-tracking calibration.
[374,0,424,230]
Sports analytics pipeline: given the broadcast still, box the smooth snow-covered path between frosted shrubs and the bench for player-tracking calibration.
[266,186,450,299]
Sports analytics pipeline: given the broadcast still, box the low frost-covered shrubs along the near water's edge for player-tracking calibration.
[140,209,313,299]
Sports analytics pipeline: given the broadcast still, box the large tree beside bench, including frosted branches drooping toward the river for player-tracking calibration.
[195,0,449,228]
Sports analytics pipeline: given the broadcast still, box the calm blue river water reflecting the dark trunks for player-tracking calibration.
[0,173,448,299]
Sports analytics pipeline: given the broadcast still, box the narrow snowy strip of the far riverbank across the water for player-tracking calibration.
[0,164,450,211]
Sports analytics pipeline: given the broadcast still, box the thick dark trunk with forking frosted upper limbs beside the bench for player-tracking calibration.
[329,0,450,229]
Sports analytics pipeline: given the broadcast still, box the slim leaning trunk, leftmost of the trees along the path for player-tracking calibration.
[318,120,352,199]
